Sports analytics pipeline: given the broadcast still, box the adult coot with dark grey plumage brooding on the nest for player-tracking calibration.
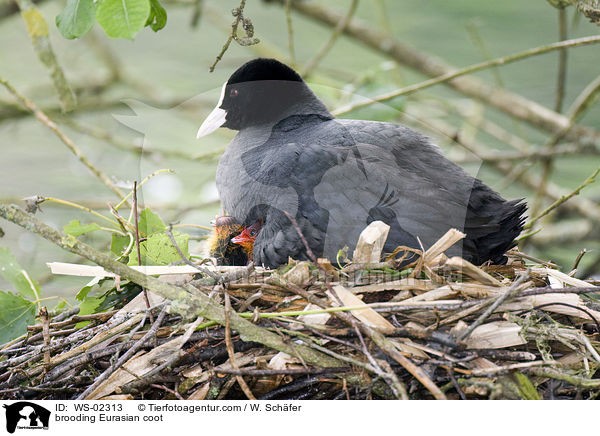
[198,58,526,267]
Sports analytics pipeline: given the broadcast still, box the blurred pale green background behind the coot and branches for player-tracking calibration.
[0,0,600,297]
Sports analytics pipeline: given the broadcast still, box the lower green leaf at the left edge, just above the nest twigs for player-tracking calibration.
[0,291,35,344]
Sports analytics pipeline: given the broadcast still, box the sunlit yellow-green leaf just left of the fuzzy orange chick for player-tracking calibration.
[128,232,190,266]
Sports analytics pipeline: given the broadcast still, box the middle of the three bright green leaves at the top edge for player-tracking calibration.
[96,0,150,39]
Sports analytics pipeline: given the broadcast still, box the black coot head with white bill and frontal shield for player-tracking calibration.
[198,58,316,137]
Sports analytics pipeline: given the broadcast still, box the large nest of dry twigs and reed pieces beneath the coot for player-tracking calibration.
[0,226,600,400]
